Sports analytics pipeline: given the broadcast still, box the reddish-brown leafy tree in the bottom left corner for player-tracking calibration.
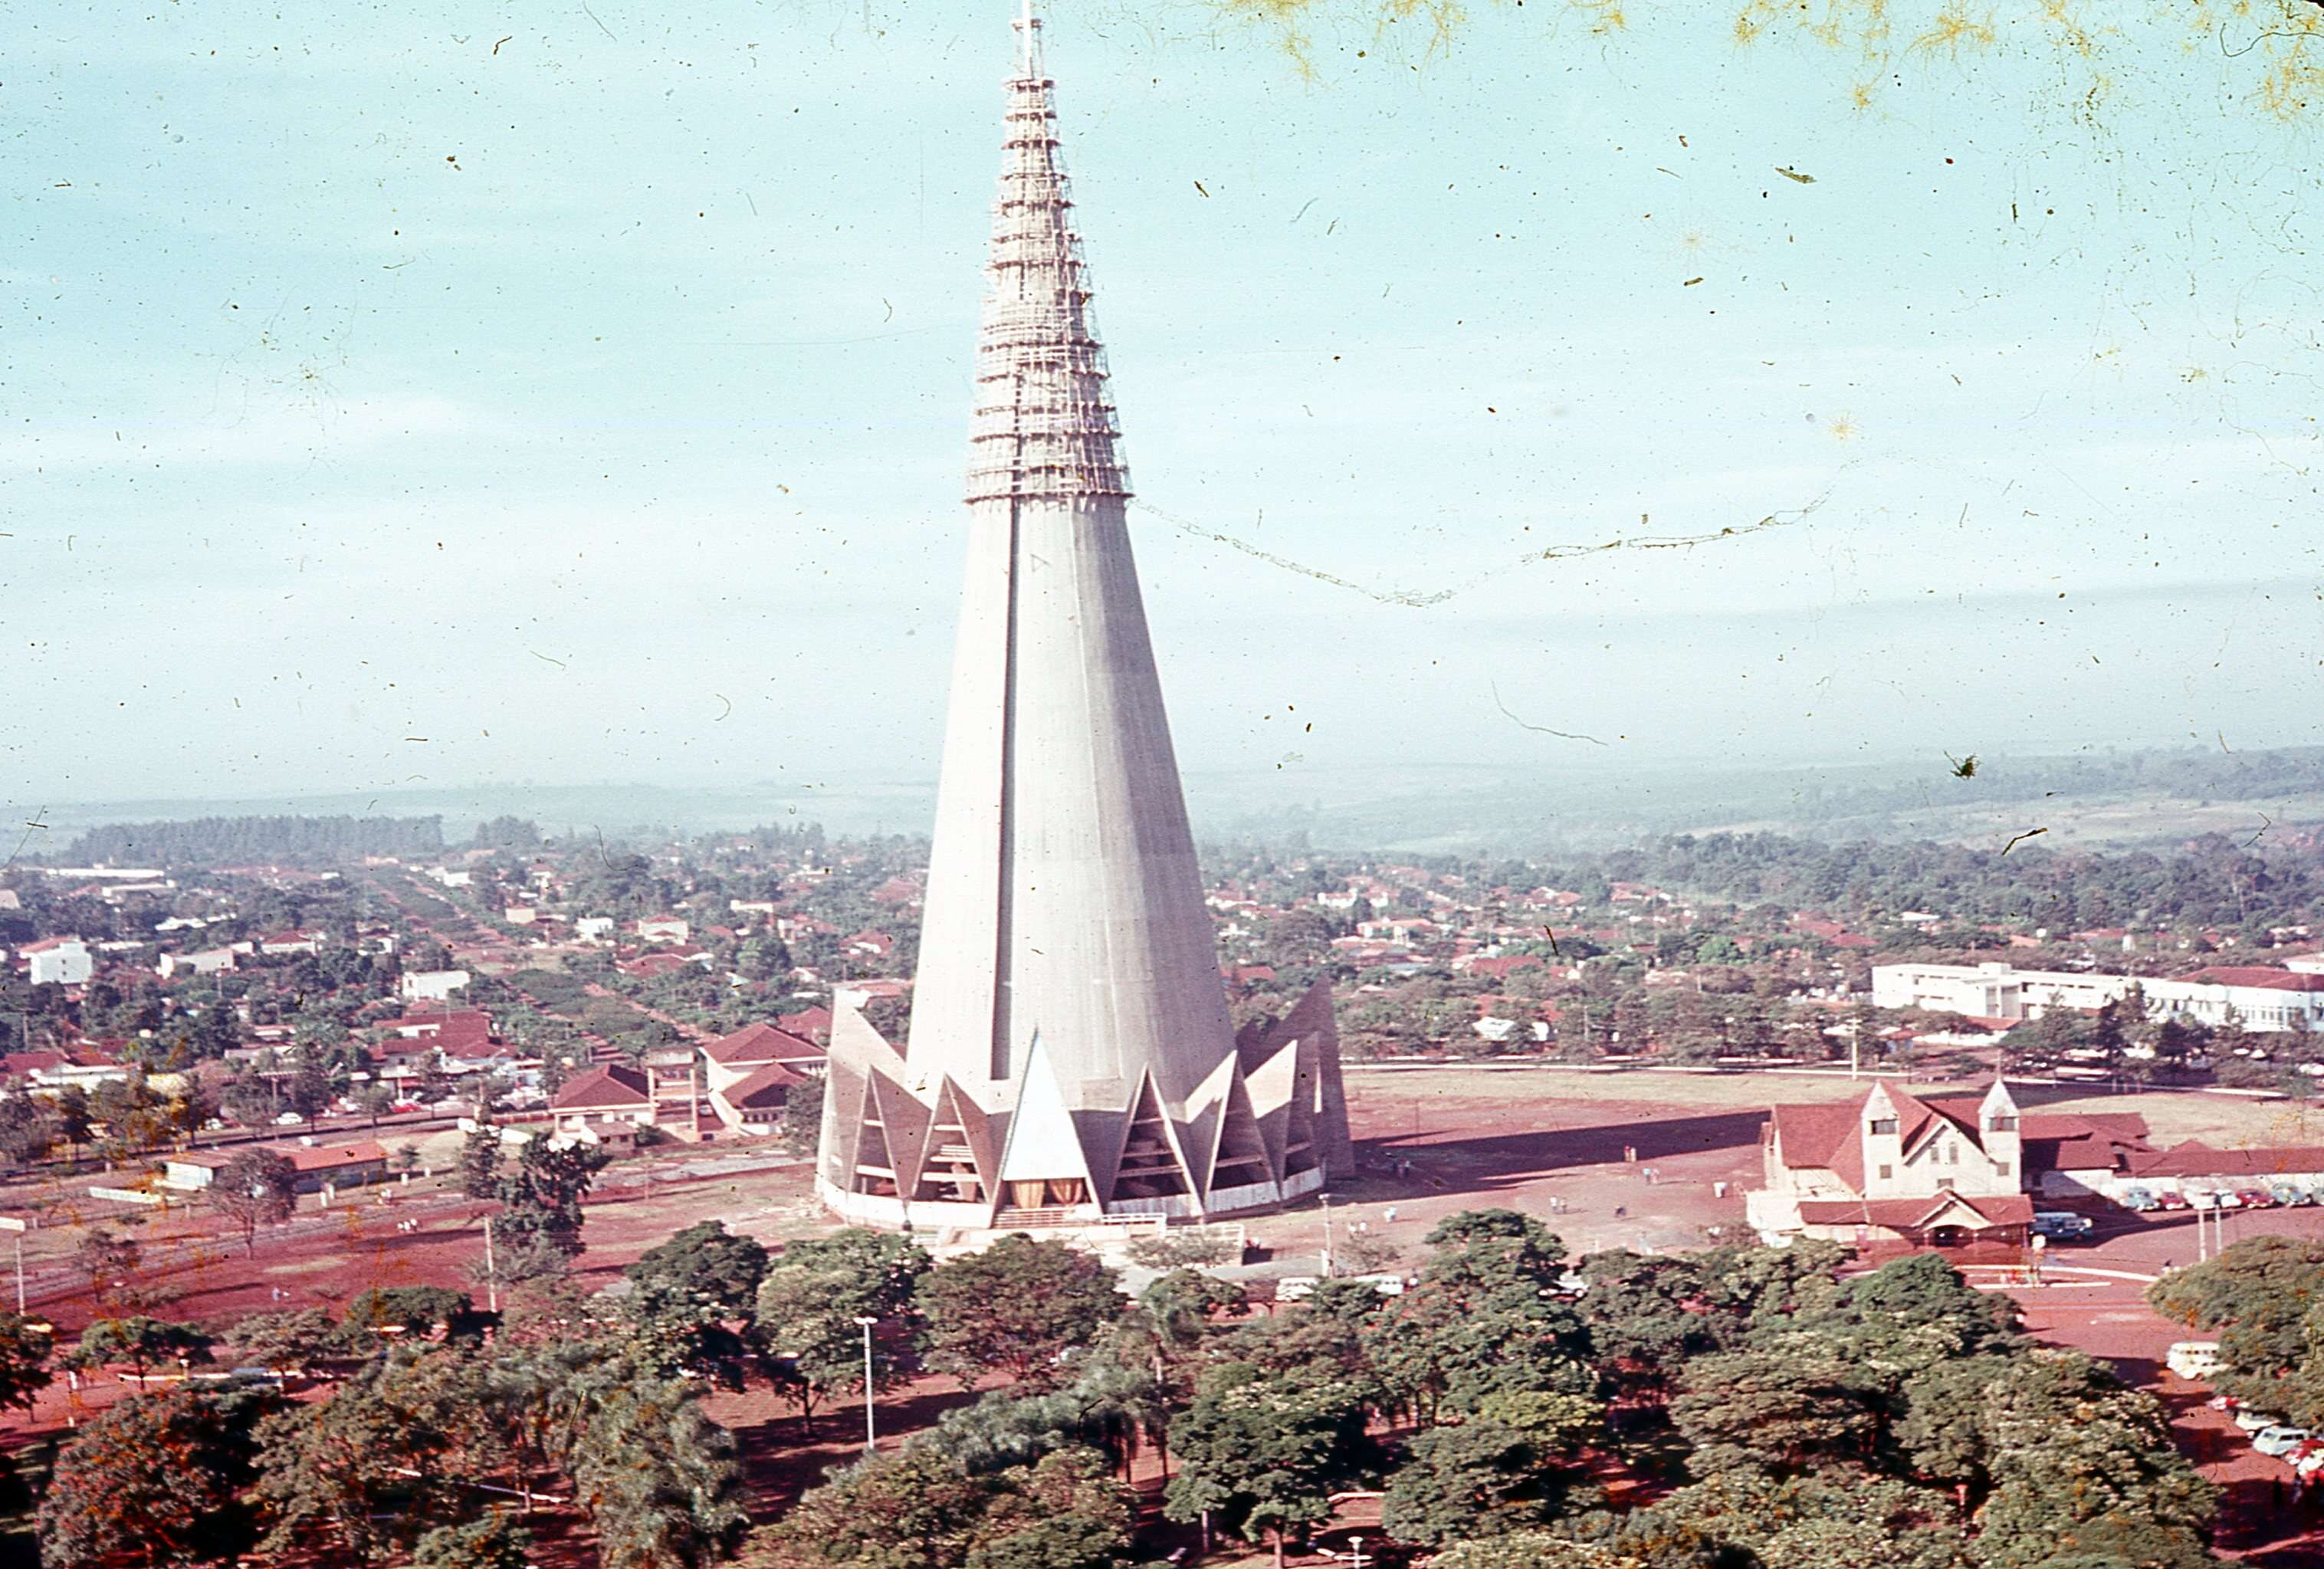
[38,1385,265,1569]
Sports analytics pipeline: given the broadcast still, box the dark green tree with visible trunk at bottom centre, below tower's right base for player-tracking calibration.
[1162,1362,1376,1567]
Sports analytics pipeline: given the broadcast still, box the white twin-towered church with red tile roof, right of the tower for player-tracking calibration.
[1745,1078,2034,1249]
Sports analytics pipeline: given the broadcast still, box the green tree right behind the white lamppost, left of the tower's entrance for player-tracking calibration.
[757,1227,932,1434]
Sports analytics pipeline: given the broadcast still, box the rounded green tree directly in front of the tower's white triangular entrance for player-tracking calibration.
[914,1232,1128,1387]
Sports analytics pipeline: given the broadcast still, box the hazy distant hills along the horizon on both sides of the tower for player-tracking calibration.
[34,746,2324,860]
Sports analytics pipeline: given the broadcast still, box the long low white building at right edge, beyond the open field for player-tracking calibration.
[1873,960,2324,1029]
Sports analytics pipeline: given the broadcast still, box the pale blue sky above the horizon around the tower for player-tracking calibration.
[0,0,2324,822]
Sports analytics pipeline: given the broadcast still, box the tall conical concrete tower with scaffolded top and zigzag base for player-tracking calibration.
[822,5,1353,1225]
